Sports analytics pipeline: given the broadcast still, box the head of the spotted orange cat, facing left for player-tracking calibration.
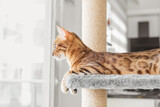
[52,26,75,59]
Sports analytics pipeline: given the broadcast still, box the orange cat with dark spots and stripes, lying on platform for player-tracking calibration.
[52,26,160,94]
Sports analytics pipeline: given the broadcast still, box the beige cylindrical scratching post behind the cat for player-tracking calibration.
[82,0,107,107]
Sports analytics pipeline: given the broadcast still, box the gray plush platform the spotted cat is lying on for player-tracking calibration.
[66,75,160,89]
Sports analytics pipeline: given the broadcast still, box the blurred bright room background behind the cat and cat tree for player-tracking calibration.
[0,0,160,107]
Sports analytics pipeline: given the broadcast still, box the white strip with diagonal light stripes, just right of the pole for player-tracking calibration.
[108,0,128,52]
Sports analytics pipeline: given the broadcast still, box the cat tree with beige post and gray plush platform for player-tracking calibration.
[66,0,160,107]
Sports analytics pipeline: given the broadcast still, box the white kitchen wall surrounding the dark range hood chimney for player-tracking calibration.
[127,0,160,38]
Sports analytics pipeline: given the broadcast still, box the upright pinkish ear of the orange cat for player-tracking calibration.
[57,25,73,40]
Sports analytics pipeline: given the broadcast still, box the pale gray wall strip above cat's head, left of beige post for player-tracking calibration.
[63,0,82,37]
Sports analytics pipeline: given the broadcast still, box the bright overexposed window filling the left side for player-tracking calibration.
[0,0,51,107]
